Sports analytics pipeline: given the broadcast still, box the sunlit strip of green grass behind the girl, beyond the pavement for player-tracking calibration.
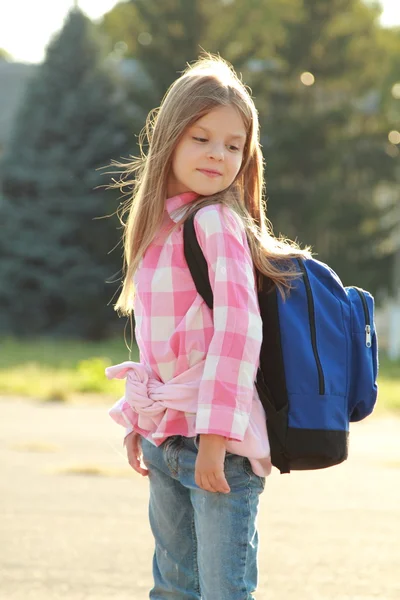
[0,338,400,415]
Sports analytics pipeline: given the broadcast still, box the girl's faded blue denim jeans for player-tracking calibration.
[142,436,265,600]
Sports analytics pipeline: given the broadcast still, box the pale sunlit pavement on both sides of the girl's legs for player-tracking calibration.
[0,398,400,600]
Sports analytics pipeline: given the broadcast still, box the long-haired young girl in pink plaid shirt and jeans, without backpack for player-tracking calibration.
[107,55,307,600]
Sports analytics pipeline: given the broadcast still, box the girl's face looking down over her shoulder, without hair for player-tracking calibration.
[168,105,246,197]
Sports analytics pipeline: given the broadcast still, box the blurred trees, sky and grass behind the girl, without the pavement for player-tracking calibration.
[0,0,400,406]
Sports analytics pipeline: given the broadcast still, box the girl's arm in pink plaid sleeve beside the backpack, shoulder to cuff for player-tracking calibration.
[194,204,262,441]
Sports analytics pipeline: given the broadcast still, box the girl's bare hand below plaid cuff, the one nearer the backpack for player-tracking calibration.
[195,434,231,494]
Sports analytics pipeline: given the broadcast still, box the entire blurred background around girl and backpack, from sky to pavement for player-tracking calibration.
[0,0,400,600]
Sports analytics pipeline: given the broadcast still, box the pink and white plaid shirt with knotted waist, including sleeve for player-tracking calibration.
[106,192,271,476]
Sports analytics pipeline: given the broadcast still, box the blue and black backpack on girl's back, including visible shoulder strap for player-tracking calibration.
[183,214,378,473]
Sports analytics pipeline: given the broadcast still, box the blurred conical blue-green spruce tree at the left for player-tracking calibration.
[0,9,129,338]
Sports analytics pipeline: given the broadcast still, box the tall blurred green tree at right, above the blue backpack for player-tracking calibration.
[263,0,396,291]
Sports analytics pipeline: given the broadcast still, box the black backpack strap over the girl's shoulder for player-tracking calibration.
[183,212,214,309]
